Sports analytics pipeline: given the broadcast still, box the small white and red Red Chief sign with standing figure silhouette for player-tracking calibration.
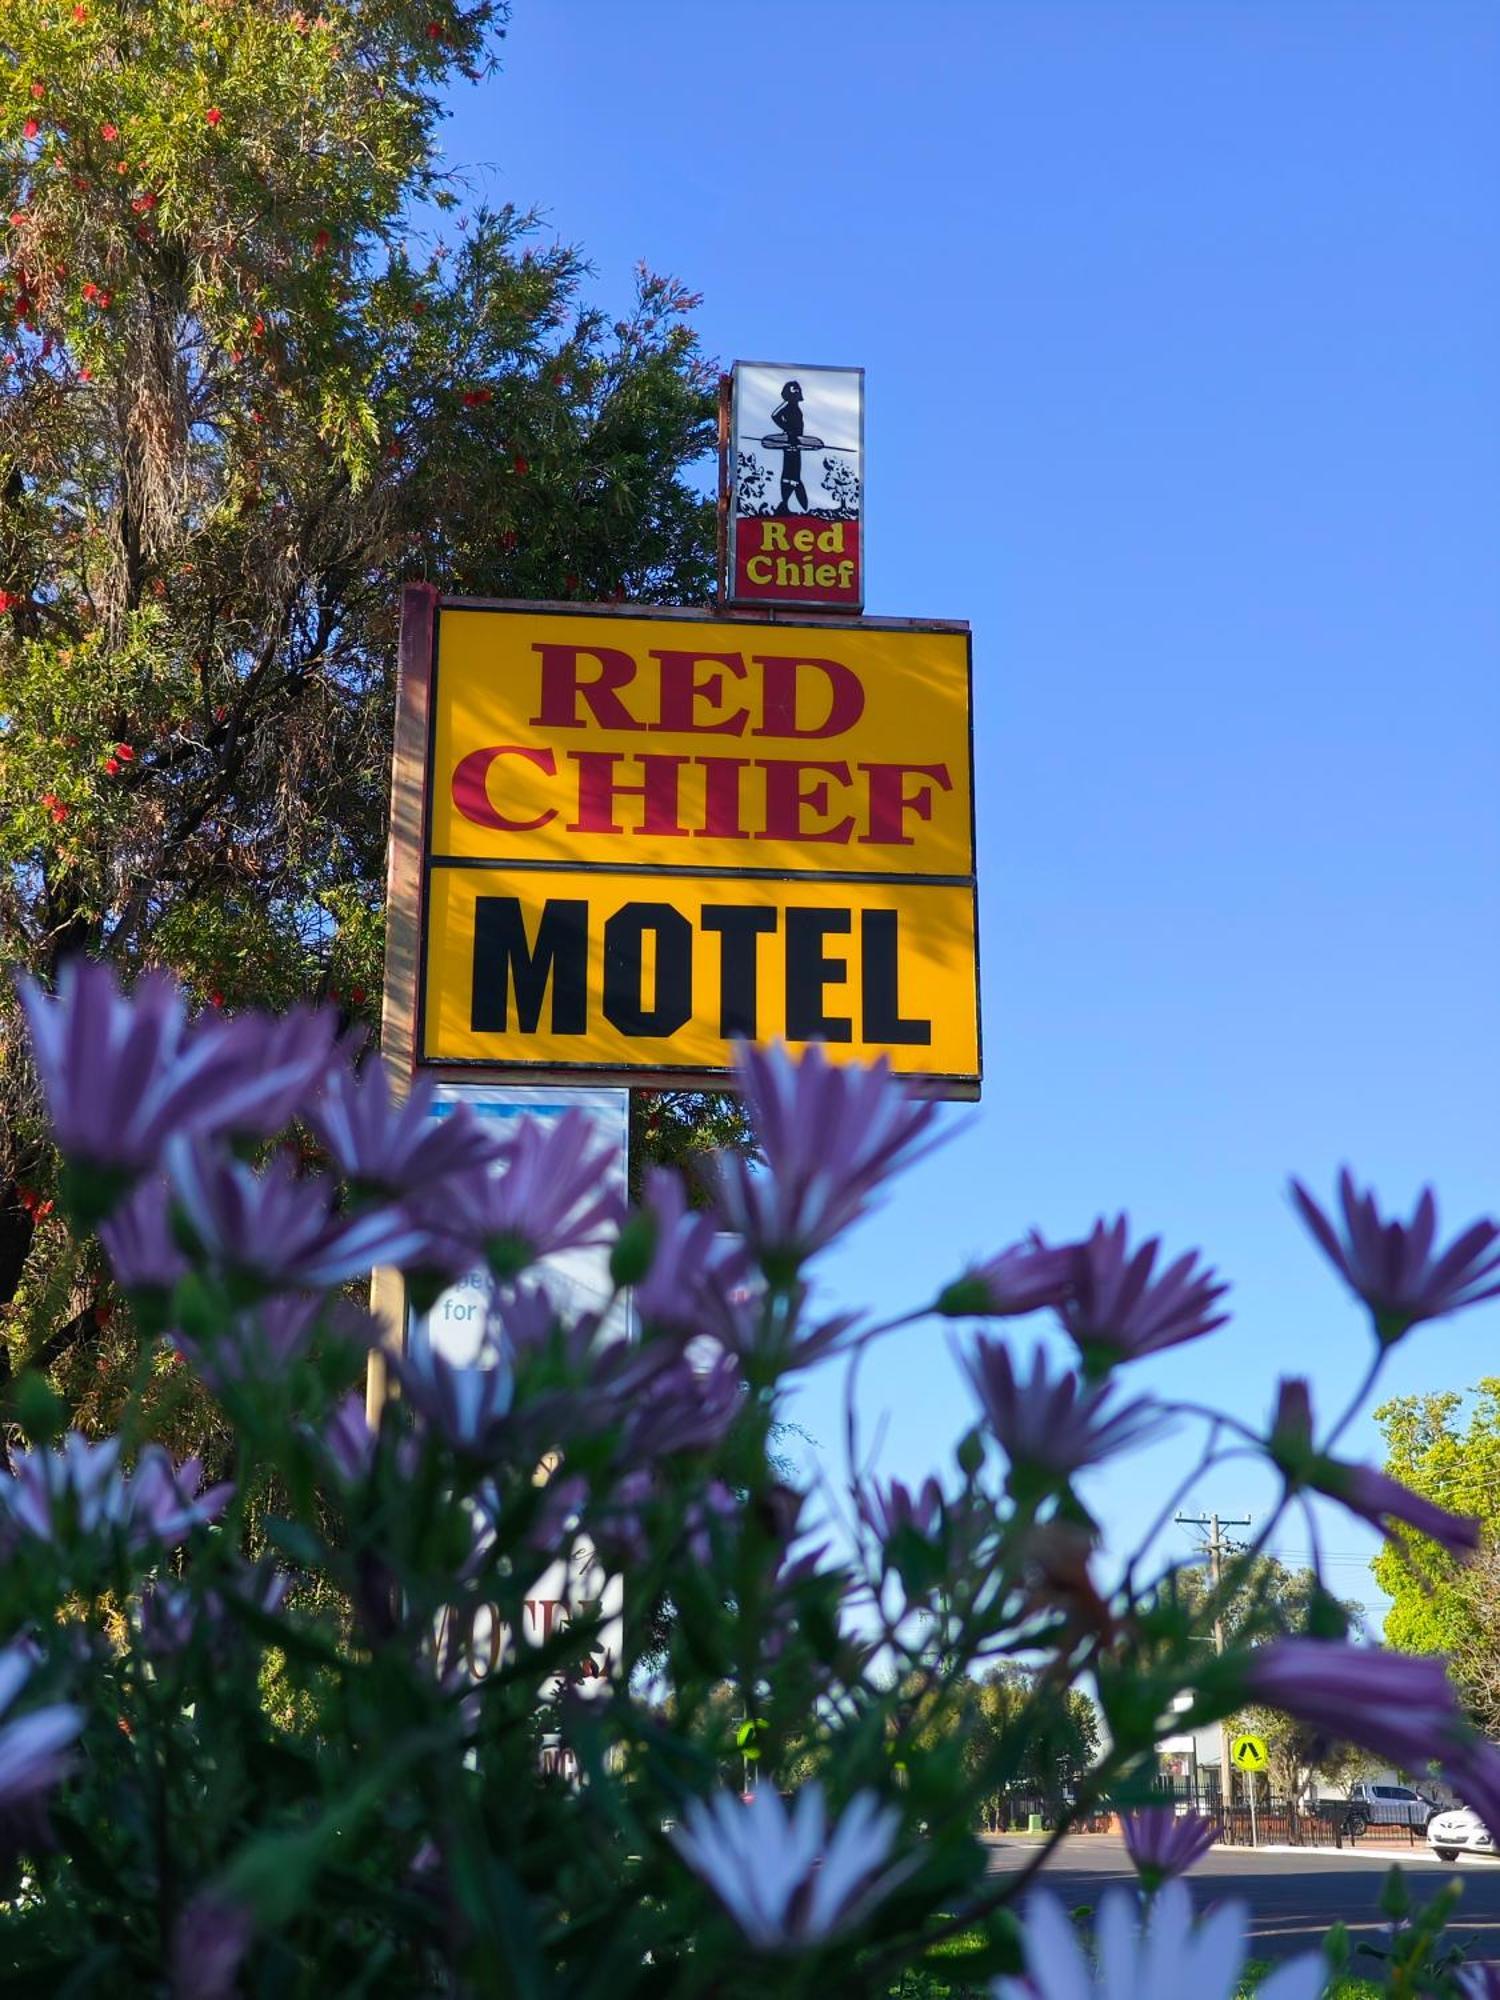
[724,362,864,612]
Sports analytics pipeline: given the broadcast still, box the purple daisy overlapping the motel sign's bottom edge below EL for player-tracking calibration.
[718,1046,938,1284]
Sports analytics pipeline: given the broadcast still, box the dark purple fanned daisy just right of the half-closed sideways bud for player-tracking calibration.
[1056,1216,1228,1376]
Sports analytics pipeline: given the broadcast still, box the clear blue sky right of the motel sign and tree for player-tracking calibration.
[446,0,1500,1604]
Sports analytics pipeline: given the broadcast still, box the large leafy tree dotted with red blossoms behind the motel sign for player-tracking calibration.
[0,0,742,1416]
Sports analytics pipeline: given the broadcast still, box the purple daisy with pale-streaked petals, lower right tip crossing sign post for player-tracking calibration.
[168,1140,428,1292]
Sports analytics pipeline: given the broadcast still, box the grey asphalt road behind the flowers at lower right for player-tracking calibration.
[990,1834,1500,1960]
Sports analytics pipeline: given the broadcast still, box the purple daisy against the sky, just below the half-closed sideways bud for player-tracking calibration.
[964,1338,1162,1486]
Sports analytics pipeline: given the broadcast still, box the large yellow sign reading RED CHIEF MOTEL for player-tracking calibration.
[390,592,980,1096]
